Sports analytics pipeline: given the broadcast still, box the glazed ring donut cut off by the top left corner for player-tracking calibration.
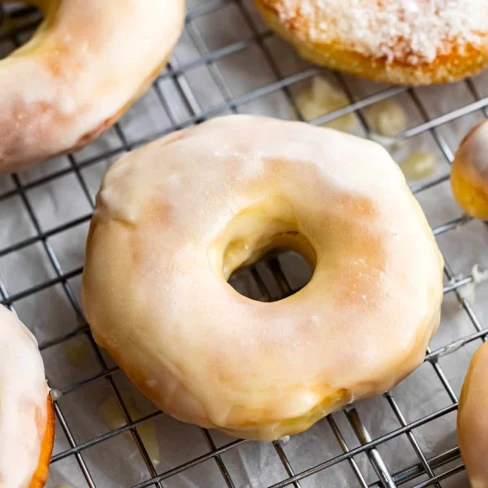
[0,0,185,173]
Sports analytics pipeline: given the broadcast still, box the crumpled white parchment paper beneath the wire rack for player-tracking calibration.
[0,0,488,488]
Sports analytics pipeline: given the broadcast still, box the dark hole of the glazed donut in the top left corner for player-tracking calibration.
[0,0,43,59]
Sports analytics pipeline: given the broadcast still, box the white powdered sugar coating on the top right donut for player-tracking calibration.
[267,0,488,65]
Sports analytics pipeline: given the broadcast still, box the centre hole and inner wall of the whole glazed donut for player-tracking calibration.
[208,197,316,300]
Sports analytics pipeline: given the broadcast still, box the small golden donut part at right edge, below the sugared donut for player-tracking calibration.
[451,121,488,220]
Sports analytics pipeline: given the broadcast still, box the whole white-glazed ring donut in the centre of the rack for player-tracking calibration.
[82,116,443,440]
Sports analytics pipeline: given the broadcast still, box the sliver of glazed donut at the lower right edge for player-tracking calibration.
[457,343,488,488]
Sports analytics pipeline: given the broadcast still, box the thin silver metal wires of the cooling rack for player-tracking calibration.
[0,0,488,488]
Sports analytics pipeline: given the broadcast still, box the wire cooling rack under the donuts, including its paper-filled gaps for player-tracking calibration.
[0,0,488,488]
